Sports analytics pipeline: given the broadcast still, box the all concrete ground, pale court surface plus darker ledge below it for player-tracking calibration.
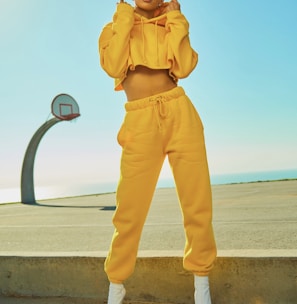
[0,180,297,304]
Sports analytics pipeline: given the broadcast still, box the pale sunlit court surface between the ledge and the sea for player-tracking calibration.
[0,180,297,255]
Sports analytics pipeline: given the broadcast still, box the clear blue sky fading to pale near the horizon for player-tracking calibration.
[0,0,297,195]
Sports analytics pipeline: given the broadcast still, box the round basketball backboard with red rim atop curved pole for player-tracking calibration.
[51,94,80,121]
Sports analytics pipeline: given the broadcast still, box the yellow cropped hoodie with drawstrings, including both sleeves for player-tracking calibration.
[99,3,198,91]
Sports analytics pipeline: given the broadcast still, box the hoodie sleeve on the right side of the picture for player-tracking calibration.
[165,10,198,78]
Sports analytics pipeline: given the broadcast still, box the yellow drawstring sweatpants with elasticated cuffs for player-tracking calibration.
[105,87,216,283]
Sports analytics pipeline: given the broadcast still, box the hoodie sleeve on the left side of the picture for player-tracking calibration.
[99,3,134,78]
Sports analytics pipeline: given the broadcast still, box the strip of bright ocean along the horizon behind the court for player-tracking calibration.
[0,169,297,204]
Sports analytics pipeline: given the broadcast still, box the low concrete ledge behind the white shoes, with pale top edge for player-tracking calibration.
[0,250,297,304]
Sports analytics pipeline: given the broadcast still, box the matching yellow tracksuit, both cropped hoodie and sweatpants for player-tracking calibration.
[99,3,216,283]
